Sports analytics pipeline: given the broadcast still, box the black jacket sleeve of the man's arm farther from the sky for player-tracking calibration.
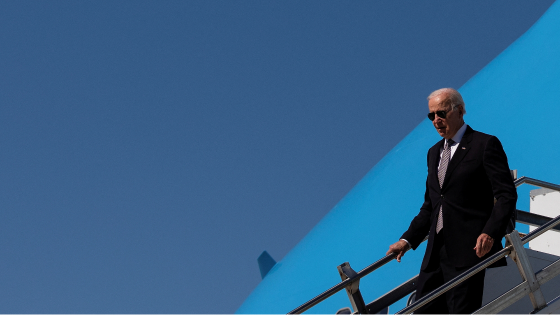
[482,137,517,240]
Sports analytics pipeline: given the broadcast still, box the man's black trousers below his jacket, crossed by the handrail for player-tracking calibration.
[414,230,486,314]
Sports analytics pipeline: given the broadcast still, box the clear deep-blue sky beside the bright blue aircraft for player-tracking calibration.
[0,0,552,313]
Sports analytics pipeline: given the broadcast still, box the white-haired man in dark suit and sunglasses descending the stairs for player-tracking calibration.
[387,88,517,314]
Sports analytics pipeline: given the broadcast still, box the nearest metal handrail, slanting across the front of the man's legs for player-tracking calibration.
[395,215,560,314]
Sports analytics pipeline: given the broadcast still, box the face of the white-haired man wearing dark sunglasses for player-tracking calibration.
[428,94,463,139]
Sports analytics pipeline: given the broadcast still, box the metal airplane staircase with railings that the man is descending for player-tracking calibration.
[288,177,560,314]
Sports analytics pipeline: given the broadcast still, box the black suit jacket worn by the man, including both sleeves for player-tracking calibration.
[401,126,517,270]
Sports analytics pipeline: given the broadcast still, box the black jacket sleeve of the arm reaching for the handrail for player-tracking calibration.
[401,151,433,250]
